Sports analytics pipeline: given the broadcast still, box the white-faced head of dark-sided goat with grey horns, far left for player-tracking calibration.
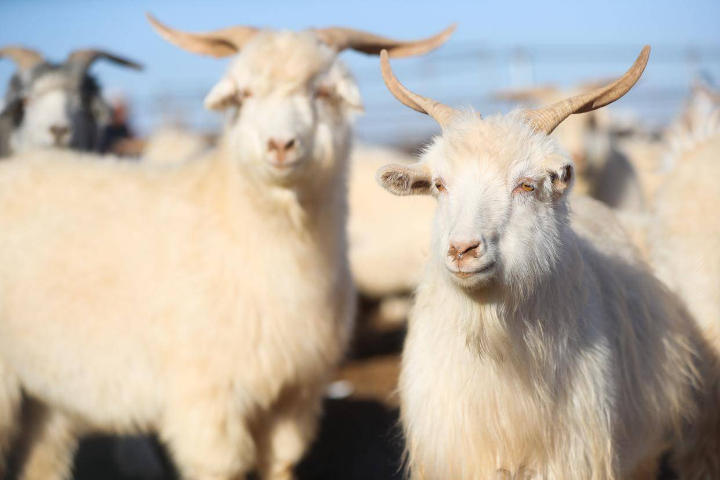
[0,47,142,157]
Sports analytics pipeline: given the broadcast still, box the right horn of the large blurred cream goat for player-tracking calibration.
[313,24,456,57]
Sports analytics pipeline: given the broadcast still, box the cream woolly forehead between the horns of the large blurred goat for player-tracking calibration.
[229,30,336,95]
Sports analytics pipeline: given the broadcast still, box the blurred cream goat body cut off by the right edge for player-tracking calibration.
[649,81,720,353]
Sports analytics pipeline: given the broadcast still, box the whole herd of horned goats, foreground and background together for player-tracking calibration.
[0,13,720,480]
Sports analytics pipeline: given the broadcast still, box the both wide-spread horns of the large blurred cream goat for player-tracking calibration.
[147,13,455,57]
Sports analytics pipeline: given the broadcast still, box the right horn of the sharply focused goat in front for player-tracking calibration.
[525,45,650,135]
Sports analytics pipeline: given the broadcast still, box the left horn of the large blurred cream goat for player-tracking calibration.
[145,13,259,57]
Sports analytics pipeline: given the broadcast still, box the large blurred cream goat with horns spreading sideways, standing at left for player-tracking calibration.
[0,15,451,480]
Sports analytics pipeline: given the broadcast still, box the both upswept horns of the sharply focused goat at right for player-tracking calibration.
[380,45,650,135]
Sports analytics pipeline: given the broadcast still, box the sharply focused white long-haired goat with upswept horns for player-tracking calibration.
[378,47,720,480]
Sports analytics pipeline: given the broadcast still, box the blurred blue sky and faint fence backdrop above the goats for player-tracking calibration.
[0,0,720,145]
